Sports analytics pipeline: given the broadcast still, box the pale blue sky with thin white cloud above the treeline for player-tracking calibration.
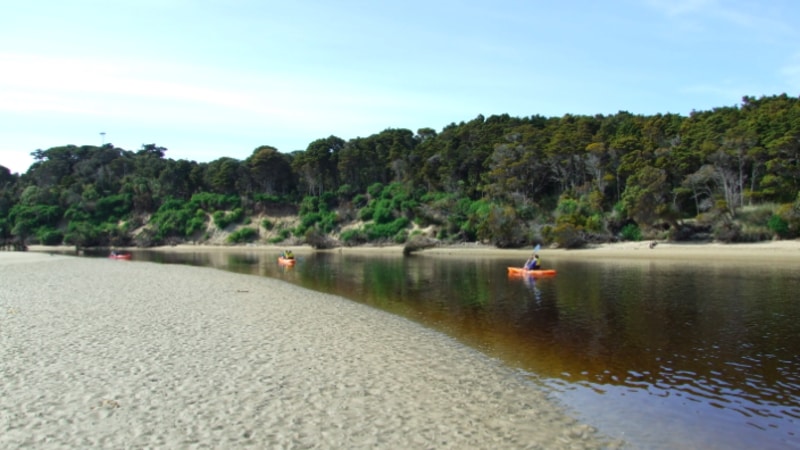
[0,0,800,173]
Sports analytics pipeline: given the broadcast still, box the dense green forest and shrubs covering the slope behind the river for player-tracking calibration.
[0,95,800,248]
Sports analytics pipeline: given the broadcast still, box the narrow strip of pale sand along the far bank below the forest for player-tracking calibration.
[29,239,800,263]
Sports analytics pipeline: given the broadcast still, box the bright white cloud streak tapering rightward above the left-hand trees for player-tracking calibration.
[0,54,444,133]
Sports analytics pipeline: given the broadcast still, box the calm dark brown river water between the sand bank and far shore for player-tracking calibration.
[101,250,800,449]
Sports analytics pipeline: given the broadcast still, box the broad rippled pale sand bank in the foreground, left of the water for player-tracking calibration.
[0,252,619,449]
